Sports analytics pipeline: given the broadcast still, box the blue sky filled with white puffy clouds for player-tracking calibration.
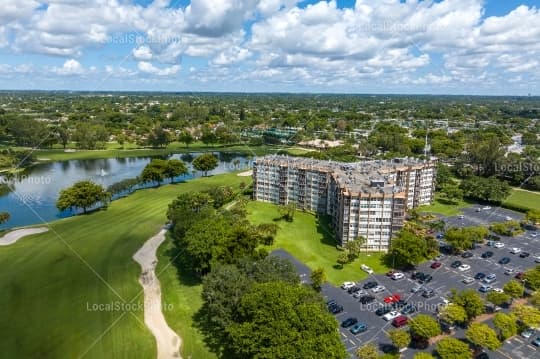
[0,0,540,95]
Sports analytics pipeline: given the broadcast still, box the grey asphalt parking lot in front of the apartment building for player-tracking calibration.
[274,208,540,359]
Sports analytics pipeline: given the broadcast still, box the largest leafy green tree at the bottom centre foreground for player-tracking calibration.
[228,282,347,359]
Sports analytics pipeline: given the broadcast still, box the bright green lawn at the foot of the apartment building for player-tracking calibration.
[248,202,387,285]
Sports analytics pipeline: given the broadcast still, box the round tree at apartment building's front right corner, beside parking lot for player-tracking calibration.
[390,230,428,266]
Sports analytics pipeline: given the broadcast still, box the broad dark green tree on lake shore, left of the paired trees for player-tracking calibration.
[56,181,111,213]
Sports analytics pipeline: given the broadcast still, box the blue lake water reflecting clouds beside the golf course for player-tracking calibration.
[0,153,252,229]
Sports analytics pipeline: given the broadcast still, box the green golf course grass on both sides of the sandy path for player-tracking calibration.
[0,174,246,358]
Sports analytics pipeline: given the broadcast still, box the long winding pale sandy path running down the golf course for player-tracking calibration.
[133,228,182,359]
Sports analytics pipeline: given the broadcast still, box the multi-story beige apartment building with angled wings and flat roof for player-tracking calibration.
[253,156,436,251]
